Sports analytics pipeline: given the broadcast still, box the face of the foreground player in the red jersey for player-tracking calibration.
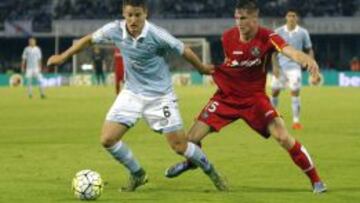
[235,9,258,35]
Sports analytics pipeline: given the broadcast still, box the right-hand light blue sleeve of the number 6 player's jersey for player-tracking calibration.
[156,29,185,55]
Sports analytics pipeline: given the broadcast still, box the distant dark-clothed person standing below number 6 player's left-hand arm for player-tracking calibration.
[93,46,105,85]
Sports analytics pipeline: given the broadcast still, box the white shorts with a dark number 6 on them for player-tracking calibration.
[106,89,183,133]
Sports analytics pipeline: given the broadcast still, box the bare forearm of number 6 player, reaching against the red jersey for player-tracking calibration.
[183,46,215,75]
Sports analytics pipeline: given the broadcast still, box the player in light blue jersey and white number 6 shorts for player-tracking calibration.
[48,0,227,191]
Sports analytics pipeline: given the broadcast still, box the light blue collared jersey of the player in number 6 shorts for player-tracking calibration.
[92,20,185,96]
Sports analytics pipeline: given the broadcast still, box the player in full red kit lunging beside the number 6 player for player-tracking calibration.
[165,0,326,193]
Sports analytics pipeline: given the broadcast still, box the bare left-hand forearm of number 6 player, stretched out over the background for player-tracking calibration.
[47,34,92,66]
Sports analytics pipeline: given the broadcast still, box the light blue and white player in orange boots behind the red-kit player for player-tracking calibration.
[271,9,314,130]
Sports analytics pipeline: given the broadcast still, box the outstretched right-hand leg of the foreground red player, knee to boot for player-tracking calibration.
[268,117,326,193]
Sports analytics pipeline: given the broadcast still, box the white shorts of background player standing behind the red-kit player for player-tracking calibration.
[271,68,301,91]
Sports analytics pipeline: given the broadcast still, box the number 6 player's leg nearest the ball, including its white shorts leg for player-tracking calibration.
[101,91,147,192]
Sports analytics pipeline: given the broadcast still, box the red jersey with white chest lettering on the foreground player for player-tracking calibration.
[213,27,287,99]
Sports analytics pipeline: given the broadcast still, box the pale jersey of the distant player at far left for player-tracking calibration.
[22,46,42,70]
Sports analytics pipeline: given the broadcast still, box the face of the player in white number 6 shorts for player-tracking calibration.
[123,5,147,37]
